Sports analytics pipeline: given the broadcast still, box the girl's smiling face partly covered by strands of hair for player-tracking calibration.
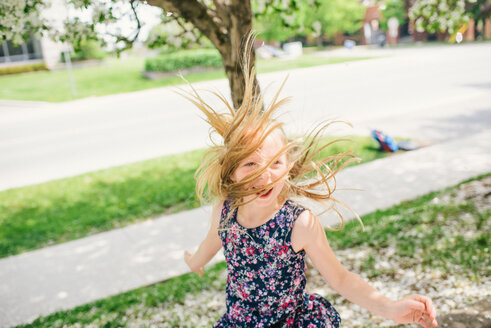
[231,133,288,207]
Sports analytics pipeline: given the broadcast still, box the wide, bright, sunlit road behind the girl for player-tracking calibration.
[0,42,491,190]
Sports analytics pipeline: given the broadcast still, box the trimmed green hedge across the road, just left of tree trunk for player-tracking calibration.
[145,49,222,72]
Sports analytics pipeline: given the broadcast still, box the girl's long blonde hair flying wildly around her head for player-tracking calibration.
[180,36,363,231]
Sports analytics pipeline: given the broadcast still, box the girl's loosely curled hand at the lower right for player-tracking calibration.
[388,294,438,328]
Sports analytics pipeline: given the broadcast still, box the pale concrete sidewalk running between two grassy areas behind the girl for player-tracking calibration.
[0,131,491,327]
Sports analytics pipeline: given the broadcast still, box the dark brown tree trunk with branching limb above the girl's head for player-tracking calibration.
[147,0,260,109]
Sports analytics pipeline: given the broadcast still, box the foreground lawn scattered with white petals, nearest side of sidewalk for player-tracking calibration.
[17,174,491,328]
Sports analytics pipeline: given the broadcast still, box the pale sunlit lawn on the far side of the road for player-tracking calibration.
[0,54,372,102]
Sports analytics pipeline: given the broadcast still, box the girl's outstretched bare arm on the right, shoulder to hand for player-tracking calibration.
[292,211,438,328]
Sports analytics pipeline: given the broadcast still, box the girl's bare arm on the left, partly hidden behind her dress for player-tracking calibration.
[184,202,223,277]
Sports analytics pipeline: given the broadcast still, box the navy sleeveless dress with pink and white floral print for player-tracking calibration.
[213,200,341,328]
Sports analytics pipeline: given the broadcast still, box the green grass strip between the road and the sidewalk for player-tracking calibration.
[0,137,386,257]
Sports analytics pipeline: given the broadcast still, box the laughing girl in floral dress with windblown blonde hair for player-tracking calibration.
[184,39,437,328]
